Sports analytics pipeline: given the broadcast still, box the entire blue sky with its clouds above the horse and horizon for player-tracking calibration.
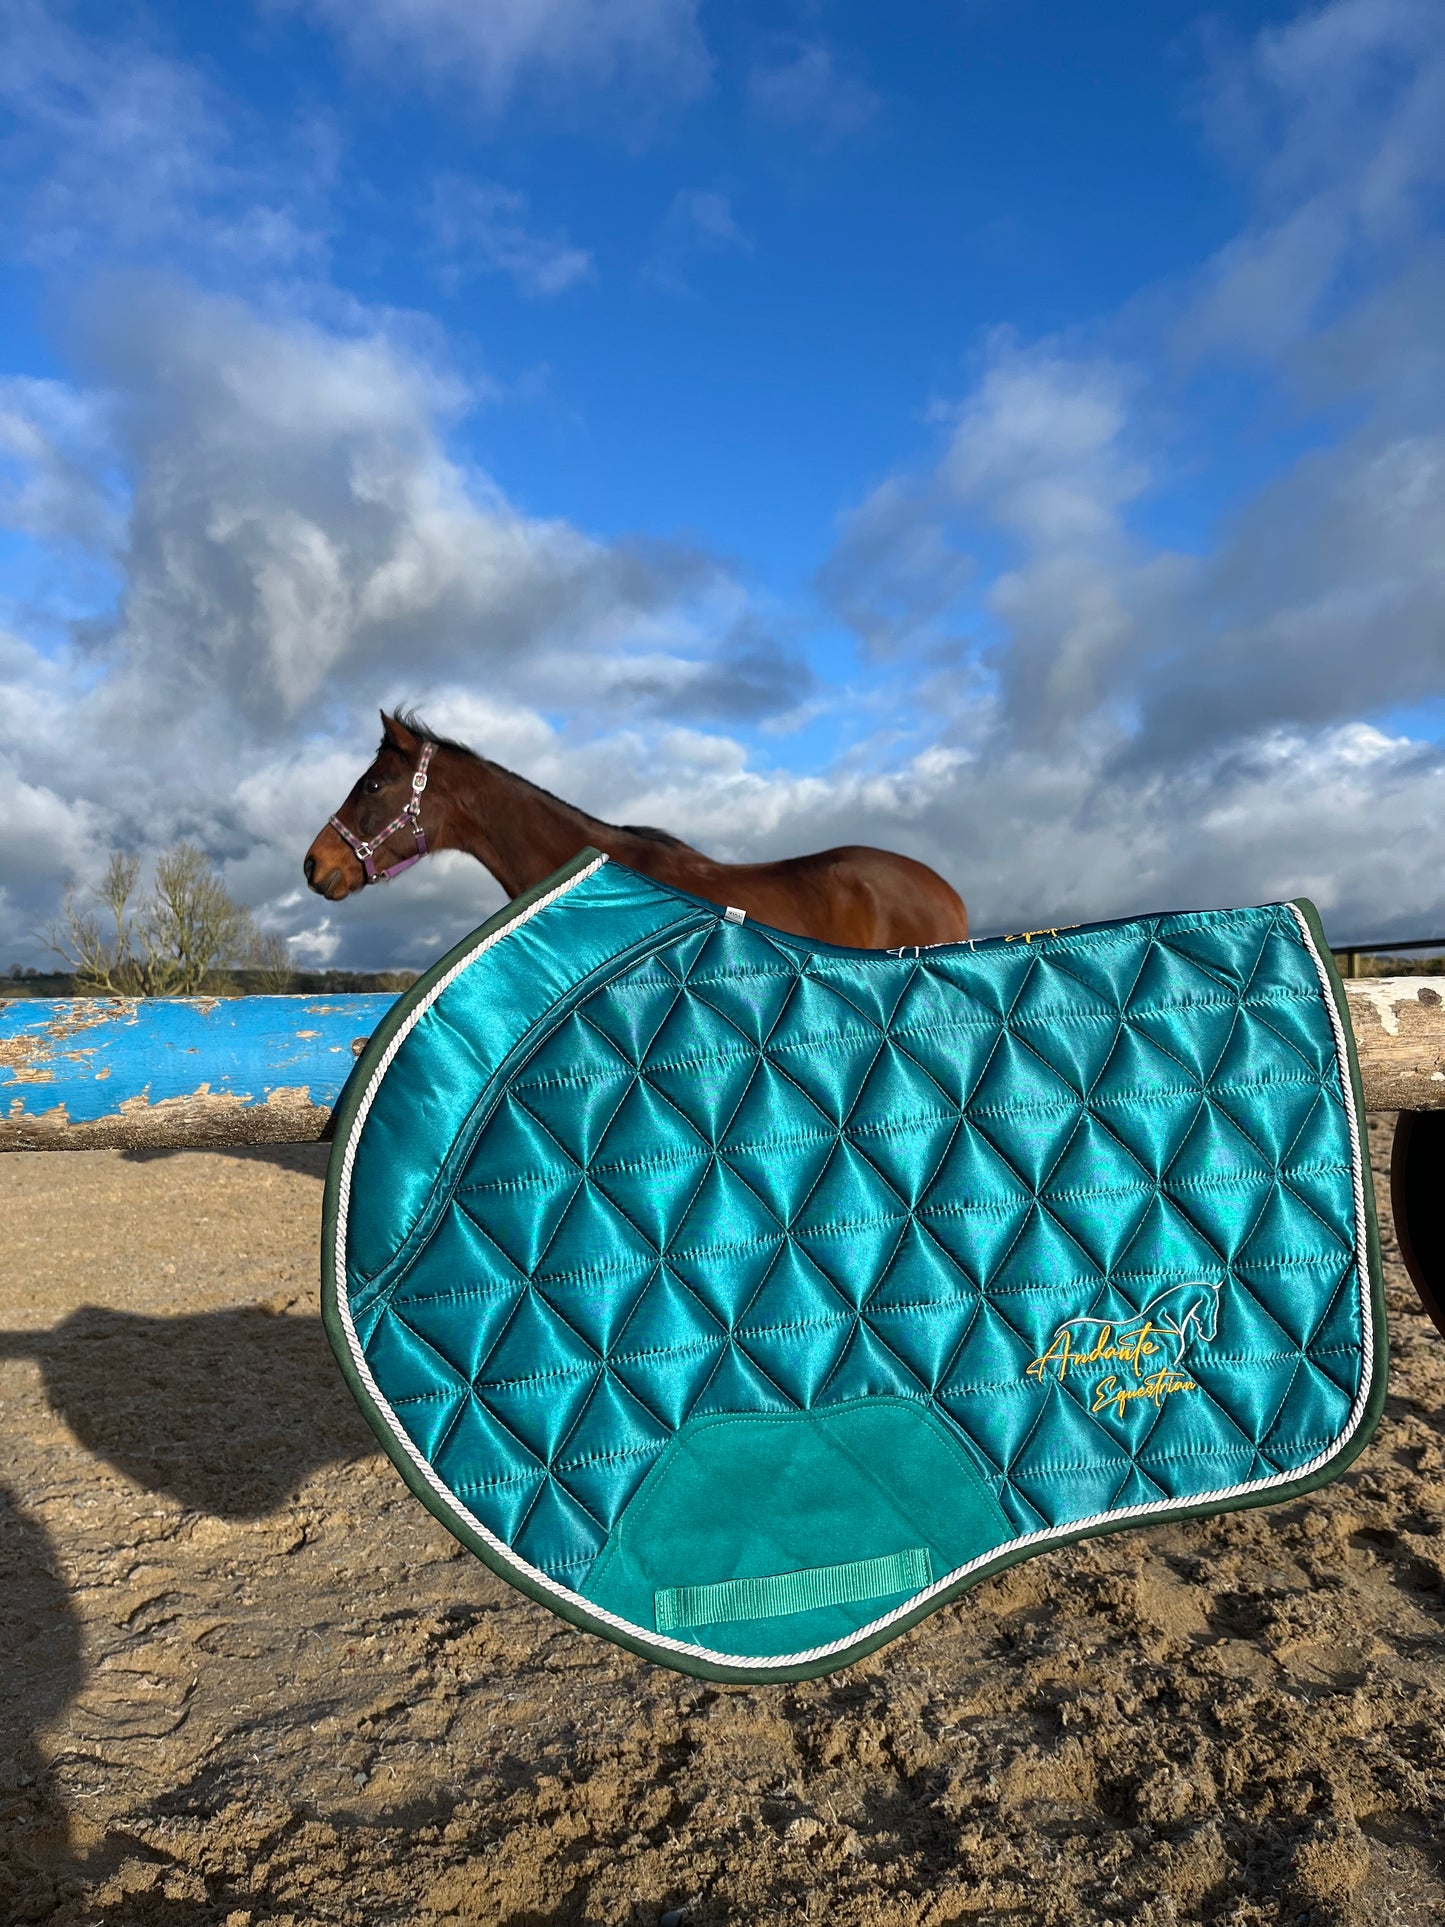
[0,0,1445,964]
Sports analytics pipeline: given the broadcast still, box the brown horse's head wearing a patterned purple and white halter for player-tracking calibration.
[301,709,439,904]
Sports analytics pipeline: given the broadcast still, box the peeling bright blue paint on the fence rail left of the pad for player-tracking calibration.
[0,994,395,1123]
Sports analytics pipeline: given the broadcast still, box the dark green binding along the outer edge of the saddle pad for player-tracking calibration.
[322,878,1389,1686]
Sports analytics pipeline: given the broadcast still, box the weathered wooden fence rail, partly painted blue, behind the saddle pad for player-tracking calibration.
[0,977,1445,1150]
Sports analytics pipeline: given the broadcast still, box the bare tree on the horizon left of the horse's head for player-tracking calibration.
[44,842,277,996]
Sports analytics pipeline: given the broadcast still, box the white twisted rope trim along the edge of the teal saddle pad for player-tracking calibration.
[335,890,1376,1673]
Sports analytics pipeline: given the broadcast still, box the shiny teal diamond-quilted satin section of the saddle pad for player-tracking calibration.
[350,882,1364,1584]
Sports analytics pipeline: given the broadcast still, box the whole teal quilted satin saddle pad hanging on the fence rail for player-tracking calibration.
[324,852,1385,1680]
